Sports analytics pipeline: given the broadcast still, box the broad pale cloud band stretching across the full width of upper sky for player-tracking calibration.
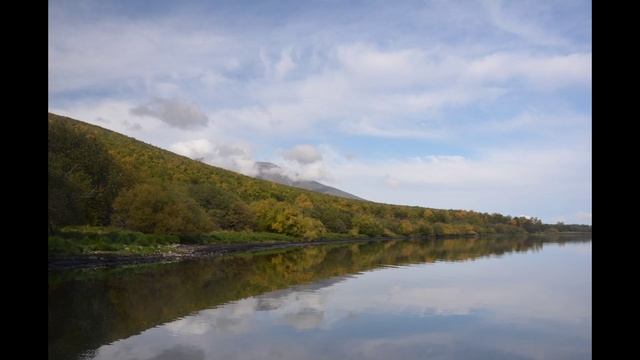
[50,17,591,137]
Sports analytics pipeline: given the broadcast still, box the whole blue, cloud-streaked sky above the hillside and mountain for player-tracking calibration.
[48,0,592,224]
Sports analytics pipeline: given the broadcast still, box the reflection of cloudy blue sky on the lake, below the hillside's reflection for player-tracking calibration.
[84,242,591,360]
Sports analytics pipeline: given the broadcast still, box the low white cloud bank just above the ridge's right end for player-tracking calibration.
[324,147,591,222]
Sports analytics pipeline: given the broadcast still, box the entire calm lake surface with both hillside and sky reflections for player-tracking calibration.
[49,235,591,359]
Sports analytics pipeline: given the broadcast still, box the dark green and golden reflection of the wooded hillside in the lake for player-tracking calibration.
[49,238,592,359]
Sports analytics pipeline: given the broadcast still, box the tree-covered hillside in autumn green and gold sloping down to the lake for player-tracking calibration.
[48,113,590,239]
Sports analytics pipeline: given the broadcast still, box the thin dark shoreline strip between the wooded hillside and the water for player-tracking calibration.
[48,232,591,271]
